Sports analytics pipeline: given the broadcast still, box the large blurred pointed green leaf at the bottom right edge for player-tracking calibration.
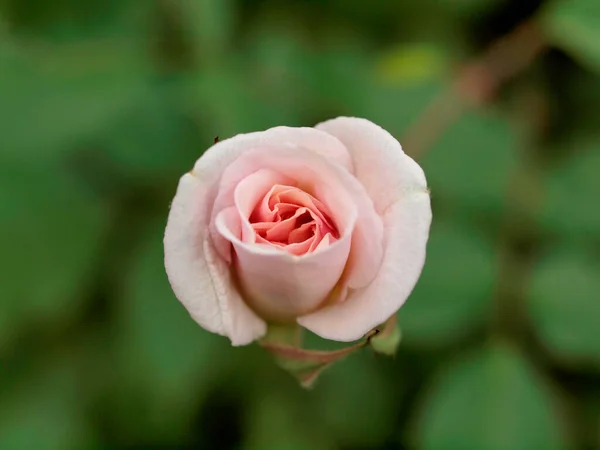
[418,344,567,450]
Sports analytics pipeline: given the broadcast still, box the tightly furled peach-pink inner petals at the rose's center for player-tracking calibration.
[243,184,339,255]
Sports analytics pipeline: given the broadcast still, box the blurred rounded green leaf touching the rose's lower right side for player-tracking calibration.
[398,220,495,346]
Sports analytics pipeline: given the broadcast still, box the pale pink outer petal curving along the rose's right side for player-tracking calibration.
[298,117,431,341]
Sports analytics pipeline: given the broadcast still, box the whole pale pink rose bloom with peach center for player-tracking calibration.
[164,117,431,345]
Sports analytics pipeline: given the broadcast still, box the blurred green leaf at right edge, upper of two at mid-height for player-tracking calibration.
[540,140,600,239]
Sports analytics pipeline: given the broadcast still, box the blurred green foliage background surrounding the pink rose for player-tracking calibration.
[0,0,600,450]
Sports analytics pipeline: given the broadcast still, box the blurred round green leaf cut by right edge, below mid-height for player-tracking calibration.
[528,250,600,368]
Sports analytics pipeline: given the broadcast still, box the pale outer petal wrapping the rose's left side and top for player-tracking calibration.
[164,127,352,345]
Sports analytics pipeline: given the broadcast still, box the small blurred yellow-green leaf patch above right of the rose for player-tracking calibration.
[375,43,446,85]
